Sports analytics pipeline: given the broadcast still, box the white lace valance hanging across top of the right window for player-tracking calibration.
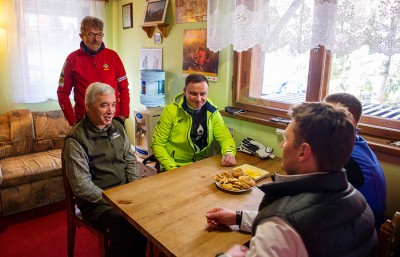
[207,0,400,56]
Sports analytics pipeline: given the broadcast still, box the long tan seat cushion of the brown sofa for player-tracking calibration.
[0,149,61,188]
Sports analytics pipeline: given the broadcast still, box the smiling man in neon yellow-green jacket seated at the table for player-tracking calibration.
[152,74,236,170]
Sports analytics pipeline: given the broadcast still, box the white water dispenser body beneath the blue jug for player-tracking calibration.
[134,108,163,158]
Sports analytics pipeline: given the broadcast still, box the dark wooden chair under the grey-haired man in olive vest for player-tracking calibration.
[62,159,108,257]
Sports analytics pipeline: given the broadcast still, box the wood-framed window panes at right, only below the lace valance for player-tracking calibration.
[233,46,400,140]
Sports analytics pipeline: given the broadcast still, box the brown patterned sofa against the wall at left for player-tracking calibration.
[0,109,70,215]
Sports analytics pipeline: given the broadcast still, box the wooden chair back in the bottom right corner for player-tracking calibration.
[378,212,400,257]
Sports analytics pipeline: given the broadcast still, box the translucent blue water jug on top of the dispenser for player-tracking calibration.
[140,69,165,107]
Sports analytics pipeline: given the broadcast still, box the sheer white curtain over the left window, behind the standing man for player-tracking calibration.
[5,0,105,103]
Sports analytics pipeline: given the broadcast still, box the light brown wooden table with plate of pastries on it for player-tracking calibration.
[103,152,281,257]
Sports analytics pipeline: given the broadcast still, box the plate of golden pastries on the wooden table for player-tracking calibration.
[214,171,256,193]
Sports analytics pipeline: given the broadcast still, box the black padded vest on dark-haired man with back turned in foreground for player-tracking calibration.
[253,171,378,257]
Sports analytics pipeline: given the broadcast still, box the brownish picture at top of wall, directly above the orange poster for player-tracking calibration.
[175,0,207,24]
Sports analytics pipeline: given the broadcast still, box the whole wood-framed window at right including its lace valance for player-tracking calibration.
[207,0,400,144]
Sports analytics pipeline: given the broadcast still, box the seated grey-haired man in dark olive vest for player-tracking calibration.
[62,82,146,257]
